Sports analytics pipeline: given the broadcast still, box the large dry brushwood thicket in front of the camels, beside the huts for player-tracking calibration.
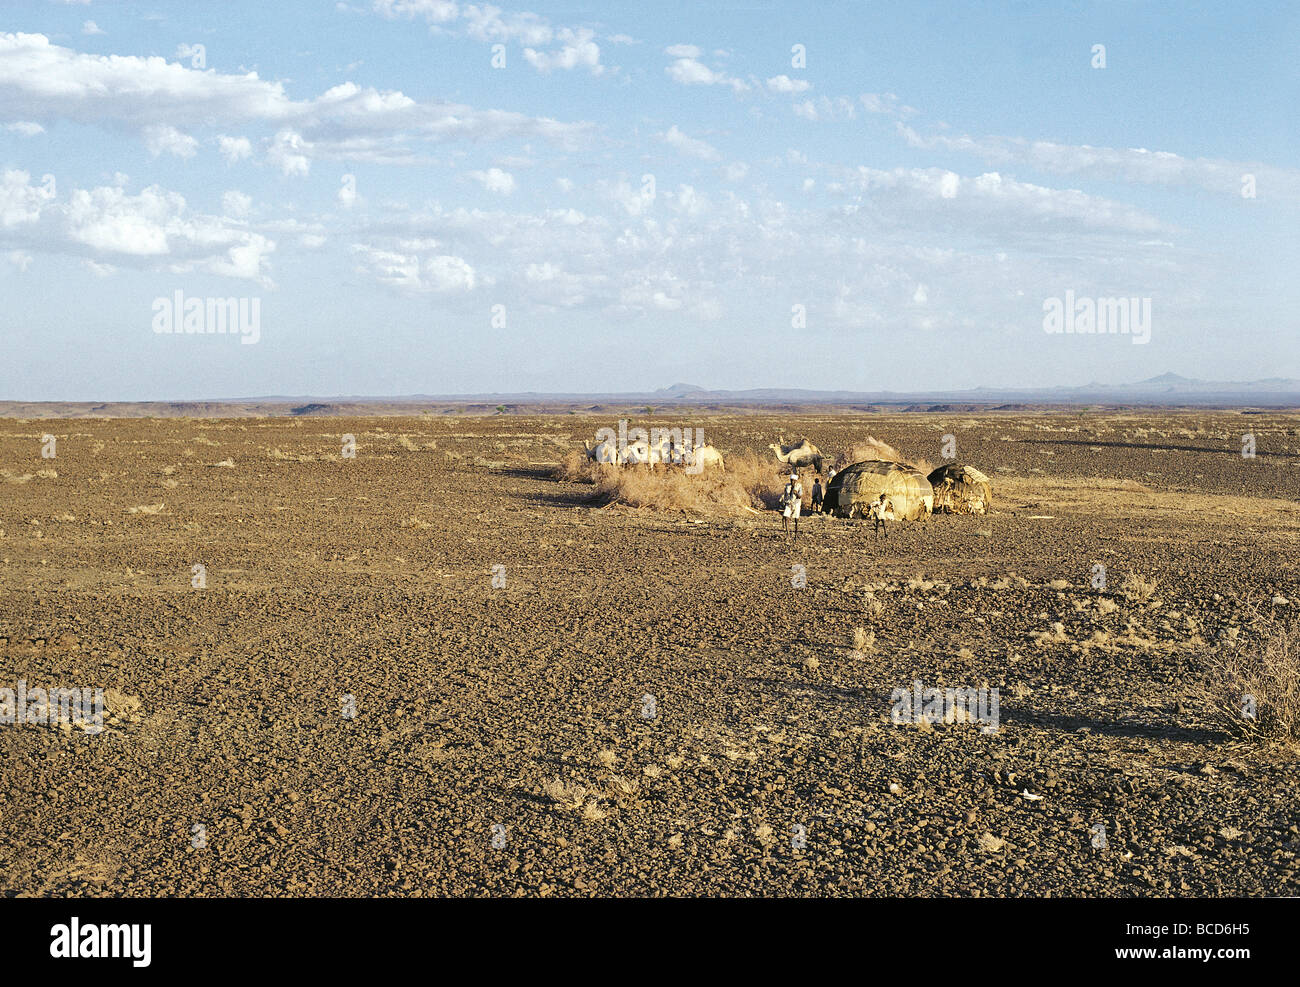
[555,450,784,514]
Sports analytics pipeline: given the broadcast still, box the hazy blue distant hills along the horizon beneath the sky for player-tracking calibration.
[0,373,1300,417]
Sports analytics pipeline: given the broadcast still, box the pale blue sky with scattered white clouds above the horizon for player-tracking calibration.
[0,0,1300,401]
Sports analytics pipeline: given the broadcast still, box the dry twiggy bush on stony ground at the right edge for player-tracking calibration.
[1206,615,1300,744]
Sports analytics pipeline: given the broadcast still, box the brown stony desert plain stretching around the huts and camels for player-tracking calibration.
[0,411,1300,897]
